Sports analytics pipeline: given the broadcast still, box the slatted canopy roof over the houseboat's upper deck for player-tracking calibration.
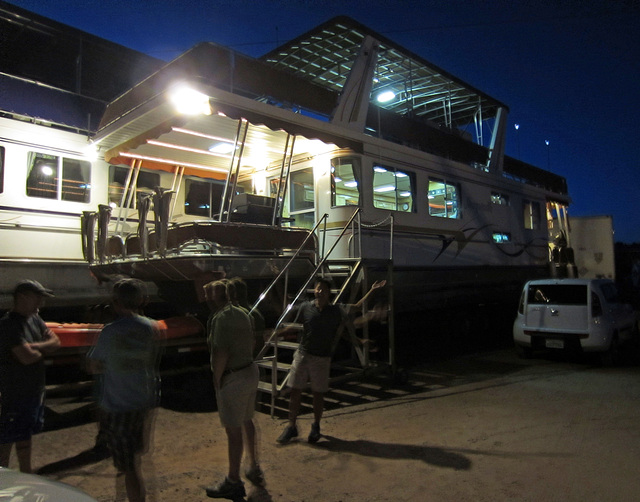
[261,16,507,129]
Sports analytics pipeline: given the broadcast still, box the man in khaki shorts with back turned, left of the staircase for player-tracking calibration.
[204,281,264,499]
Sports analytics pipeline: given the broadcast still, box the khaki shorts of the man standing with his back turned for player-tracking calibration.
[216,364,260,428]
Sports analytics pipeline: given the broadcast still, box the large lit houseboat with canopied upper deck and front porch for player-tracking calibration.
[84,17,570,318]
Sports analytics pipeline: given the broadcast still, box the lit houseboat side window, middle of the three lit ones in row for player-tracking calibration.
[373,164,415,213]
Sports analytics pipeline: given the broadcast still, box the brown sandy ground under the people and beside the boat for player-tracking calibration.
[12,350,640,502]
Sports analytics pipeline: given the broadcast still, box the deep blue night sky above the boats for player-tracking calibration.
[9,0,640,243]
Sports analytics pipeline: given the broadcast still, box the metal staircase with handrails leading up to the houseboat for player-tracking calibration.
[253,210,395,416]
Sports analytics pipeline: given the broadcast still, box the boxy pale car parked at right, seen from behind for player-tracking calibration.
[513,279,638,364]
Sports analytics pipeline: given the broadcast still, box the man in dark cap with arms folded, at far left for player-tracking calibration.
[0,280,60,472]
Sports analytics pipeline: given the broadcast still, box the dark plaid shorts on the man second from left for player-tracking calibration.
[101,409,151,472]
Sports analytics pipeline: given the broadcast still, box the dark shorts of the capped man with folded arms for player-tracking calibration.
[0,391,44,444]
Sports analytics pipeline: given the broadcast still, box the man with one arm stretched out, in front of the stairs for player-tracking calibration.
[276,277,386,444]
